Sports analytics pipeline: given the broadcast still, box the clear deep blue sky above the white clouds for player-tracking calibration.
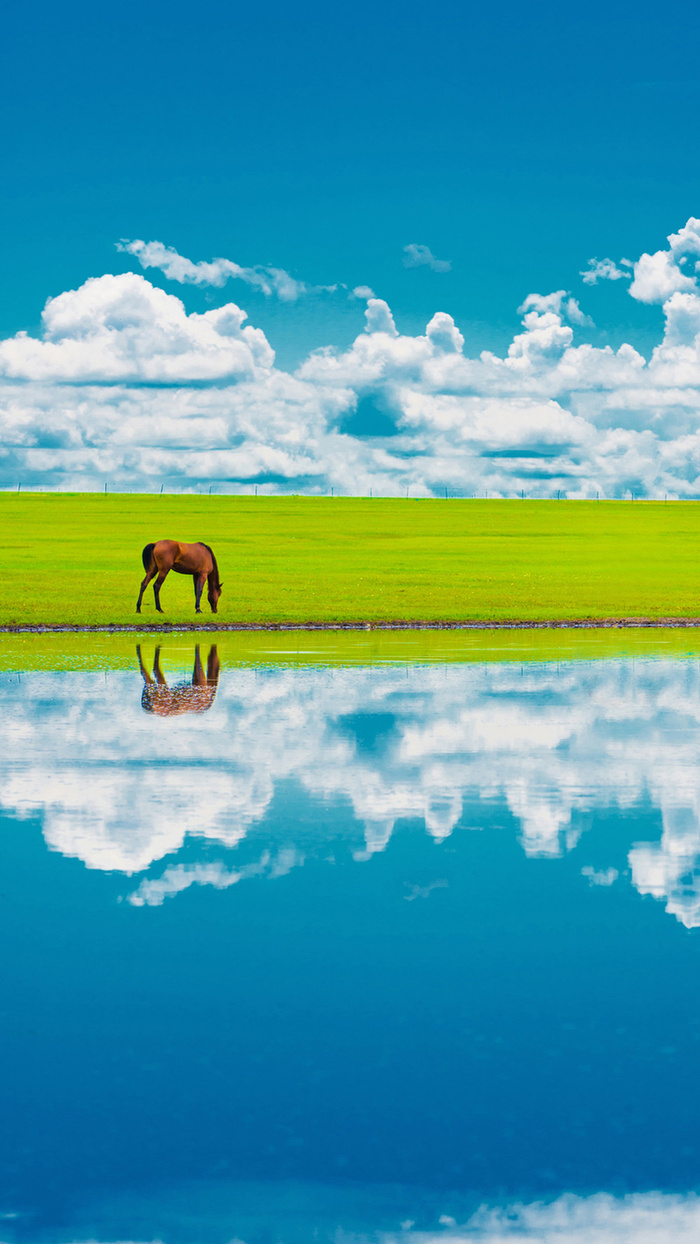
[0,0,700,488]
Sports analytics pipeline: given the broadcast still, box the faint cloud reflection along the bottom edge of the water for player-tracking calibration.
[30,1181,700,1244]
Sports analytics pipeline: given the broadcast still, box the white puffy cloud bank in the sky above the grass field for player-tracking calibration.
[0,218,700,498]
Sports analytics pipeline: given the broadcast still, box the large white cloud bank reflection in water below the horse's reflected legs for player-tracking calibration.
[0,652,700,928]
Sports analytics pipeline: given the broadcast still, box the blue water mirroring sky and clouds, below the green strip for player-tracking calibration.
[0,641,700,1244]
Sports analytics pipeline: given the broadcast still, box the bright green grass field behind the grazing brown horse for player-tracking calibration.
[0,493,700,628]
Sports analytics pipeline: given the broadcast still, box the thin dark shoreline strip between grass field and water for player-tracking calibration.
[0,617,700,636]
